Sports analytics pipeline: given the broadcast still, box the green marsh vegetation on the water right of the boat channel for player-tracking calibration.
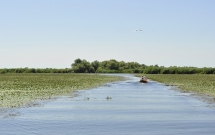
[136,74,215,97]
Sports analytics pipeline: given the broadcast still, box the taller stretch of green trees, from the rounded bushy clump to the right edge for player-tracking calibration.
[72,59,215,74]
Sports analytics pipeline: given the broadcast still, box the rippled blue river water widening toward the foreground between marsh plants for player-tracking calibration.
[0,75,215,135]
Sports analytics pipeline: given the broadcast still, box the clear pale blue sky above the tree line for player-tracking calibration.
[0,0,215,68]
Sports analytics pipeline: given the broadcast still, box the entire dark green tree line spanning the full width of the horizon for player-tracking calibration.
[0,58,215,74]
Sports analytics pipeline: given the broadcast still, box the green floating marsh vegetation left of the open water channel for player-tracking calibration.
[0,74,122,108]
